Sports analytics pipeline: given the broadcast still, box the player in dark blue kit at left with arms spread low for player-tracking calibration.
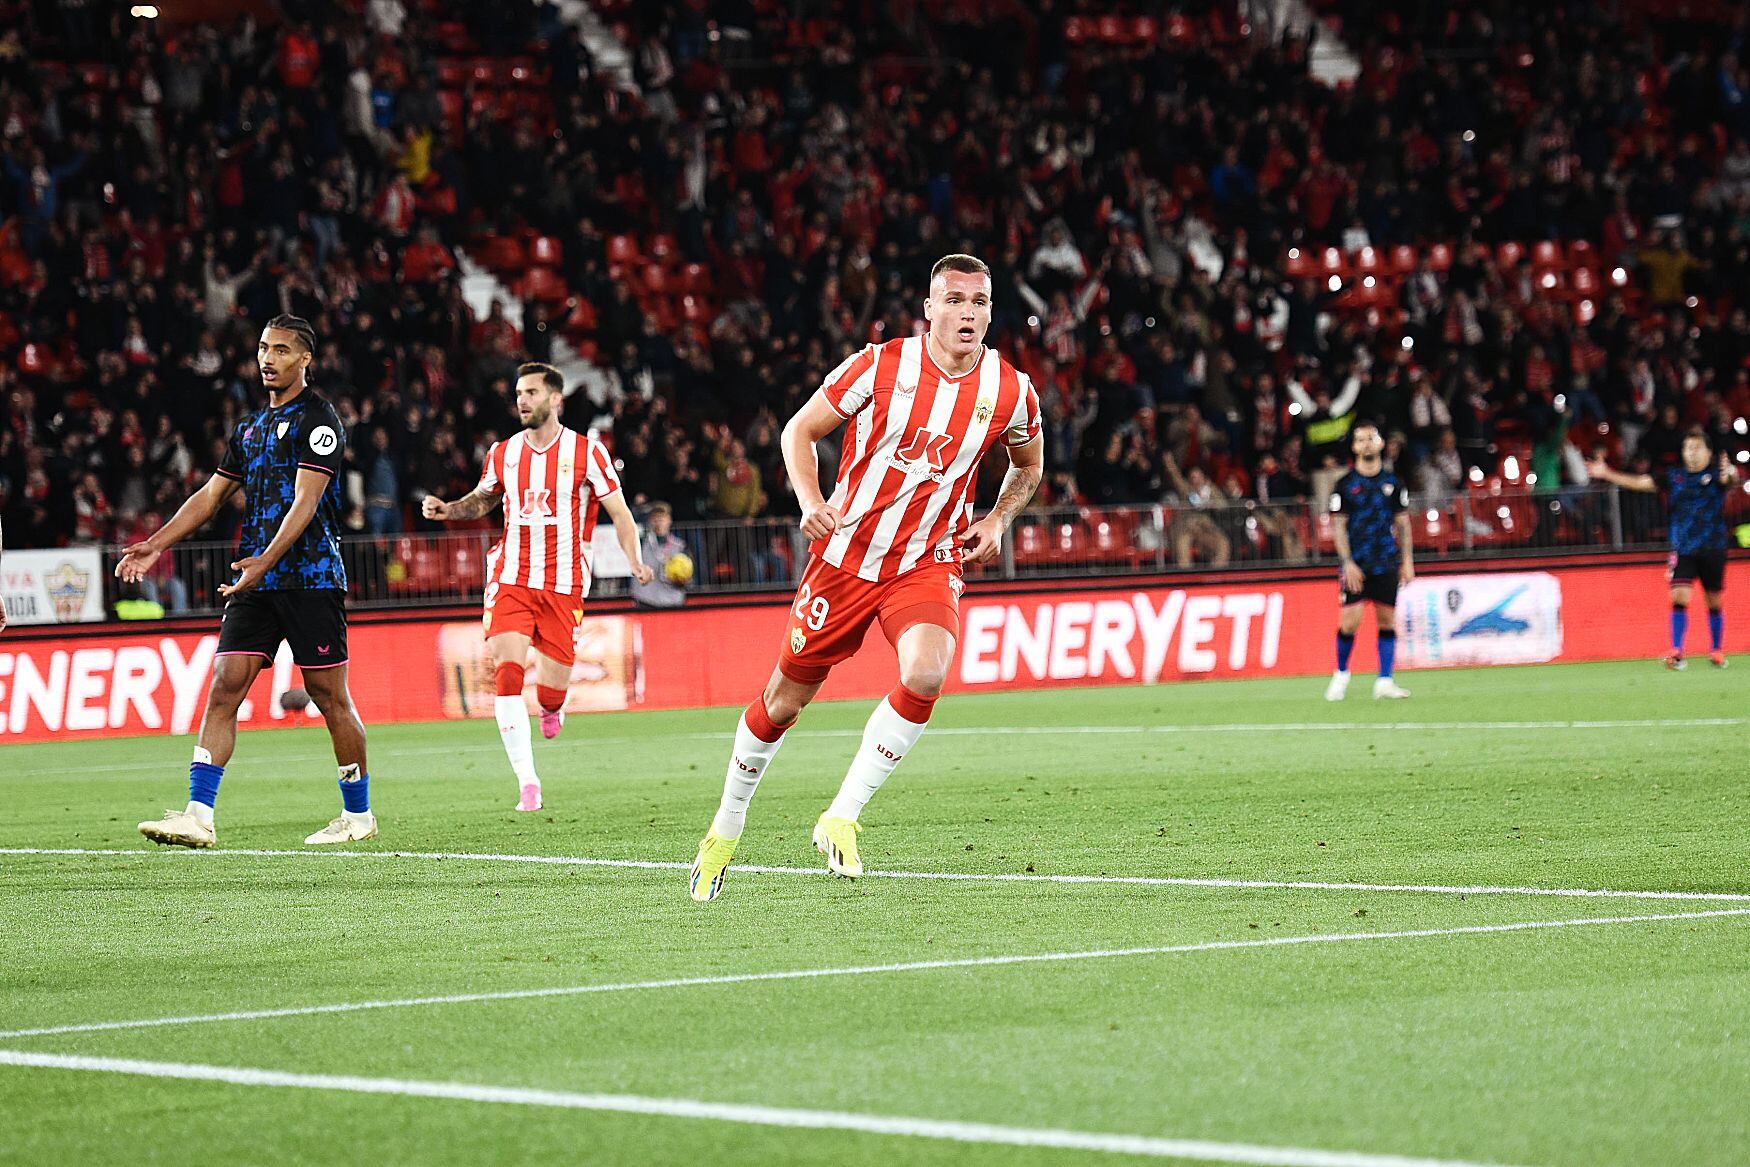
[116,315,376,847]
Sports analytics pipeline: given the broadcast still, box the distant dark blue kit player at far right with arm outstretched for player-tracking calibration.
[1587,429,1738,668]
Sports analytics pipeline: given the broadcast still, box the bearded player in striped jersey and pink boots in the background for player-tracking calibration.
[420,362,651,810]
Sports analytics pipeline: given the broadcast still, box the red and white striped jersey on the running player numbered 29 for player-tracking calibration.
[812,336,1040,581]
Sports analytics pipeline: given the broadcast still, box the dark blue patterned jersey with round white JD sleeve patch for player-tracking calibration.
[219,385,347,591]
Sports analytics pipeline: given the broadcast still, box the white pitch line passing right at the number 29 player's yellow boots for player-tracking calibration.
[13,847,1750,903]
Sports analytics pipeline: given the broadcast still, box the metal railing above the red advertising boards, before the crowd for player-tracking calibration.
[85,486,1750,614]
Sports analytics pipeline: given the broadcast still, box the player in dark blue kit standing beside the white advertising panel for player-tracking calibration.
[1325,422,1416,702]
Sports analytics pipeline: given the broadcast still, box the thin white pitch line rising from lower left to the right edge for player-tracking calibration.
[0,908,1750,1039]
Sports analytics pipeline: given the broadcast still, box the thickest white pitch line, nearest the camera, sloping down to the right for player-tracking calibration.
[0,1050,1519,1167]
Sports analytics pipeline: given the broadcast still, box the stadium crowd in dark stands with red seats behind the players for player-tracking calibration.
[0,0,1750,560]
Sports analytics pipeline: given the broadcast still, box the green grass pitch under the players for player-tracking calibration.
[0,663,1750,1167]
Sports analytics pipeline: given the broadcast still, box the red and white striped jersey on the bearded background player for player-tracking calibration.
[480,427,620,597]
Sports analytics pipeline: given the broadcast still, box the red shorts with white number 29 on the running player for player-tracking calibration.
[777,558,966,684]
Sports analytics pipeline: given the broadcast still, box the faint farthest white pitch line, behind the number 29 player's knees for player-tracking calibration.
[20,717,1750,777]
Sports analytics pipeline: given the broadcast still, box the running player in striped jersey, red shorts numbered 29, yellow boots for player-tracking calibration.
[690,255,1045,901]
